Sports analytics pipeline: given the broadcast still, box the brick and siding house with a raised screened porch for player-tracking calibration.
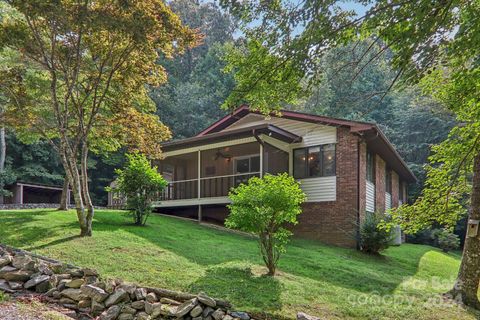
[128,106,416,247]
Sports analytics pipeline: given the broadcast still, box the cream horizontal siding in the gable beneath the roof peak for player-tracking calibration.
[223,114,337,148]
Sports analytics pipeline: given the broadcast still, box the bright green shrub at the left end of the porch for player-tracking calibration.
[107,153,167,225]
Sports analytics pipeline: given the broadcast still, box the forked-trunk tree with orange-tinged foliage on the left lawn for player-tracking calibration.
[0,0,196,236]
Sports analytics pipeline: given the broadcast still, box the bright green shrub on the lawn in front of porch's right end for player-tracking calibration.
[226,173,305,276]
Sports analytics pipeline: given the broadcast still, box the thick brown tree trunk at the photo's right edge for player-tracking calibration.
[450,153,480,309]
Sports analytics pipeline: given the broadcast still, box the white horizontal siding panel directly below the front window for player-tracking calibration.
[298,176,337,202]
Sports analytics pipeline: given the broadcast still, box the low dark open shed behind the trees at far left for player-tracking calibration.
[0,181,71,206]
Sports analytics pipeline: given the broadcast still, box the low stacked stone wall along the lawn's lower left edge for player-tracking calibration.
[0,247,253,320]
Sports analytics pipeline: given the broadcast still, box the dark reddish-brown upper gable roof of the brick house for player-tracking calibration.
[194,105,417,182]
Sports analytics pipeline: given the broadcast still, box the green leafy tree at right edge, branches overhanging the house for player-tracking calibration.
[221,0,480,307]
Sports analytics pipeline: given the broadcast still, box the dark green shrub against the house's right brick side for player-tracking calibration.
[360,212,393,254]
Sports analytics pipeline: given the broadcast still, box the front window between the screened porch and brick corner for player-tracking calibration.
[293,144,335,179]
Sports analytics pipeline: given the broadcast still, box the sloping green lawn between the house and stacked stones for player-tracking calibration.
[0,210,478,319]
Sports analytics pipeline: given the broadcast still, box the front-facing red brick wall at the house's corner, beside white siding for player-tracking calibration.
[293,128,366,247]
